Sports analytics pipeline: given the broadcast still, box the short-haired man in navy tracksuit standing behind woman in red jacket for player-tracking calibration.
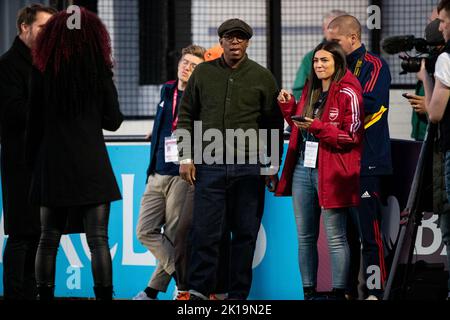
[327,15,392,300]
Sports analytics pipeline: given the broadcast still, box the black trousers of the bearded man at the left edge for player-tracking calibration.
[3,235,39,300]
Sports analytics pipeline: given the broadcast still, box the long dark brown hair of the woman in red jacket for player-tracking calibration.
[303,41,347,118]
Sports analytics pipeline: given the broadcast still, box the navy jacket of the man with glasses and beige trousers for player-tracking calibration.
[147,80,179,178]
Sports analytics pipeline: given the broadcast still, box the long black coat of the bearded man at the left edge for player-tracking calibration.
[0,37,41,236]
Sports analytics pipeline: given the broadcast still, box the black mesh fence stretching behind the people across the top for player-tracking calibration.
[0,0,438,119]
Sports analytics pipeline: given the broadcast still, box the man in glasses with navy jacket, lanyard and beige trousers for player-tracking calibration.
[133,45,206,300]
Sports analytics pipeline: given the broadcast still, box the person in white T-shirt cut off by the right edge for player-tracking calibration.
[418,0,450,300]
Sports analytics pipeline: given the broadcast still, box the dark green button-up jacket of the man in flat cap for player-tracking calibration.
[177,56,284,162]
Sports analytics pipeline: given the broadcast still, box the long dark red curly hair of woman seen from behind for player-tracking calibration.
[33,8,113,115]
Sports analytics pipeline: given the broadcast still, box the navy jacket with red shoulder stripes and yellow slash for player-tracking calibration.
[347,45,392,176]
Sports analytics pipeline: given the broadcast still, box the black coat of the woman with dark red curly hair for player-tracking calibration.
[26,68,123,208]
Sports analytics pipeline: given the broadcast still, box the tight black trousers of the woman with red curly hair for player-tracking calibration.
[36,203,112,287]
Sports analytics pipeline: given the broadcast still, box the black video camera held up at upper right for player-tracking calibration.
[381,19,445,74]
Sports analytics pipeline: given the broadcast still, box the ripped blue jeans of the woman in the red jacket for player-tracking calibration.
[292,159,350,289]
